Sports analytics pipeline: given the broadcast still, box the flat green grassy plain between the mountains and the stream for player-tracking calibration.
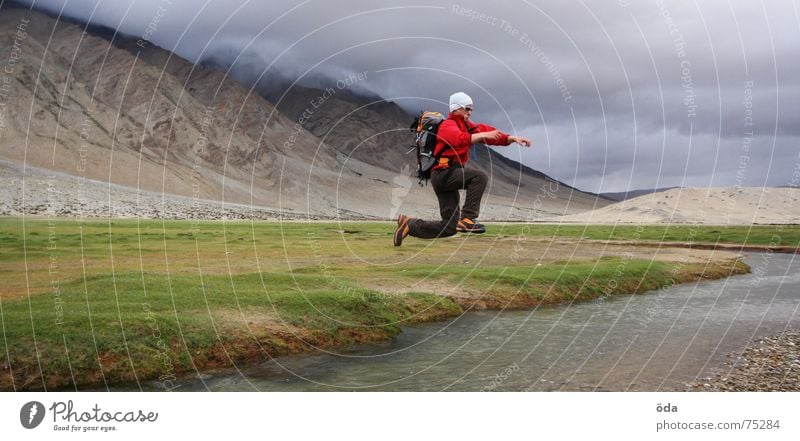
[0,218,768,390]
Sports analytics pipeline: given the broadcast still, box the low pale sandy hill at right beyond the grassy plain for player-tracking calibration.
[549,187,800,225]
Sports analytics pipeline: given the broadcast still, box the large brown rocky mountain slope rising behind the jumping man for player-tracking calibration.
[0,7,609,220]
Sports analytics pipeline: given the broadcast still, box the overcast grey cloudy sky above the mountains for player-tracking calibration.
[18,0,800,191]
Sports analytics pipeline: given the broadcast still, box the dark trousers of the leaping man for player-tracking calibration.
[408,167,489,239]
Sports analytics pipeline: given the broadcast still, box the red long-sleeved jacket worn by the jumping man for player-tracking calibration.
[433,113,511,170]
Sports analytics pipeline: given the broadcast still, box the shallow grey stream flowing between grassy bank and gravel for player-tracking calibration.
[172,253,800,391]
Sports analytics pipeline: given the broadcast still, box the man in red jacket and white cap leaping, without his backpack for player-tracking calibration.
[394,92,531,247]
